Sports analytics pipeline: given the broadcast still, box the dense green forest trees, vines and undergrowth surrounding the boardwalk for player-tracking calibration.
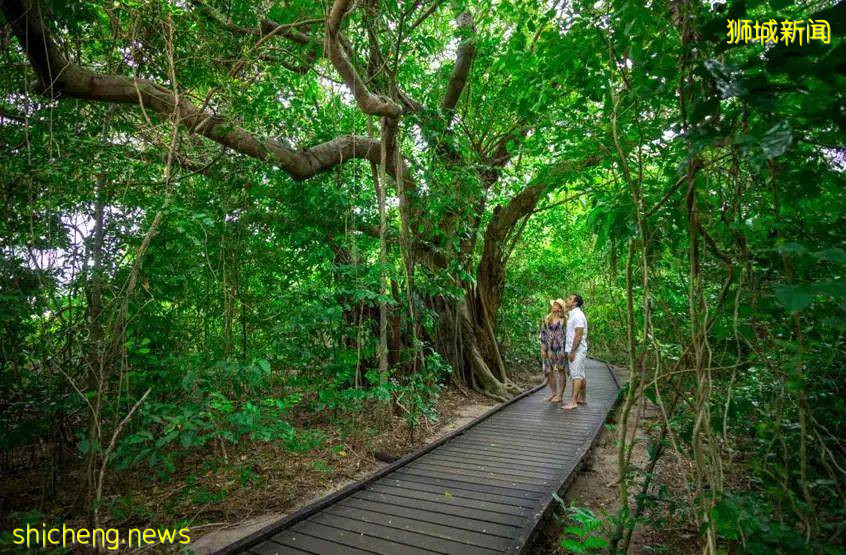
[0,0,846,552]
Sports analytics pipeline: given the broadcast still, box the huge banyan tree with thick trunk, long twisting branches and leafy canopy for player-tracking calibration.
[2,0,601,398]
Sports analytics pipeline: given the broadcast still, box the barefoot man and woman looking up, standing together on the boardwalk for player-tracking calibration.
[540,294,587,410]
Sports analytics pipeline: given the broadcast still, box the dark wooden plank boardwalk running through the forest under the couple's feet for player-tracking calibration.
[219,360,619,555]
